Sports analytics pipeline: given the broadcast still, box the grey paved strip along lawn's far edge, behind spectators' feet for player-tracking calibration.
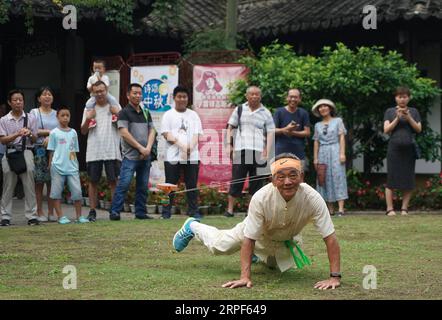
[2,199,442,226]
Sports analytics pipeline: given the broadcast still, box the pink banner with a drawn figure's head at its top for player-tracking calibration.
[193,64,248,185]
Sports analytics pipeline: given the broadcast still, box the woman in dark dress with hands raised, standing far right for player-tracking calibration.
[384,87,422,216]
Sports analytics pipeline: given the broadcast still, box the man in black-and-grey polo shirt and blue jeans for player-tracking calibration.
[109,83,156,220]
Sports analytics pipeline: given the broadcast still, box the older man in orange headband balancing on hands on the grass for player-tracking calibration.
[173,153,341,290]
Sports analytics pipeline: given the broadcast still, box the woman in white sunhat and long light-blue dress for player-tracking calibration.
[312,99,348,216]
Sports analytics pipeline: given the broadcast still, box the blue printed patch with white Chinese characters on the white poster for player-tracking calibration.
[143,75,171,112]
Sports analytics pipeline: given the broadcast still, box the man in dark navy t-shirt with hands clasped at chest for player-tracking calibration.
[273,89,310,168]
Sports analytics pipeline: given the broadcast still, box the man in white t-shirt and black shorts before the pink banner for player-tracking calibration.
[160,86,203,219]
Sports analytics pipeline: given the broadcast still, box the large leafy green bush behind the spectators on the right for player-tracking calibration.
[230,42,441,173]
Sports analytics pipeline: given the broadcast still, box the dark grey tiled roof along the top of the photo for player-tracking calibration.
[141,0,442,37]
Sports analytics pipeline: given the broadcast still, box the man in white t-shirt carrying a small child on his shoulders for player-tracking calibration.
[81,81,121,222]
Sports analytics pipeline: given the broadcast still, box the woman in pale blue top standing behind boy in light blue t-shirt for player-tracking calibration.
[30,87,58,222]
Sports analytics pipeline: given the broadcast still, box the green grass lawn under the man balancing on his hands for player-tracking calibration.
[0,215,442,300]
